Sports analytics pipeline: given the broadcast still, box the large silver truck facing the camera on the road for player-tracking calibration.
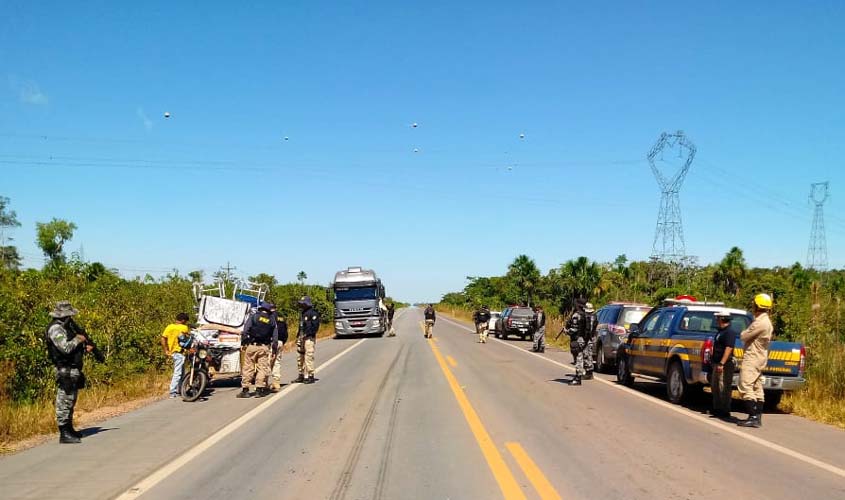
[328,267,387,337]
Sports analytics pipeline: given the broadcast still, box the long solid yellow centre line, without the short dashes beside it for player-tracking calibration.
[429,322,525,500]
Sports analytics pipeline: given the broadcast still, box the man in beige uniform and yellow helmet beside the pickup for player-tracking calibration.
[738,293,774,427]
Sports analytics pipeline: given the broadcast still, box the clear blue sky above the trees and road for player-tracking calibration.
[0,0,845,300]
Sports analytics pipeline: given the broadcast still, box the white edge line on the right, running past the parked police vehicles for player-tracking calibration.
[436,318,845,478]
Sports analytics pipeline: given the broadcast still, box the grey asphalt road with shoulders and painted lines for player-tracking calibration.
[0,309,845,500]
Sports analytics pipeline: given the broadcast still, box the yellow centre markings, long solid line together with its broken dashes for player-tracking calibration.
[420,323,561,500]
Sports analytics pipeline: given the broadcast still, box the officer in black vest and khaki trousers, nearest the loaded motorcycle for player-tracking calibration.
[237,302,279,398]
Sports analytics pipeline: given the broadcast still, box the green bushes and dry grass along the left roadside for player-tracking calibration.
[0,197,360,453]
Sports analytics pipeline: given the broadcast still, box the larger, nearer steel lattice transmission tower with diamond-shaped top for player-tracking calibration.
[648,130,696,263]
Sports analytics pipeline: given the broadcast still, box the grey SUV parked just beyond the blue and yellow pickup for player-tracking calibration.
[593,302,651,372]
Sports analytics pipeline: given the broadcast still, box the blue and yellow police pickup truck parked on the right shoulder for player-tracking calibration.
[616,299,805,409]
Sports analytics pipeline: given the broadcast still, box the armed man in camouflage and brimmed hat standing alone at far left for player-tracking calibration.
[45,301,94,444]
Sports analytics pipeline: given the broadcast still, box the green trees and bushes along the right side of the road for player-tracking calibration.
[438,252,845,428]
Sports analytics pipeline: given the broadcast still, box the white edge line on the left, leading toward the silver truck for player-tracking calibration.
[116,339,367,500]
